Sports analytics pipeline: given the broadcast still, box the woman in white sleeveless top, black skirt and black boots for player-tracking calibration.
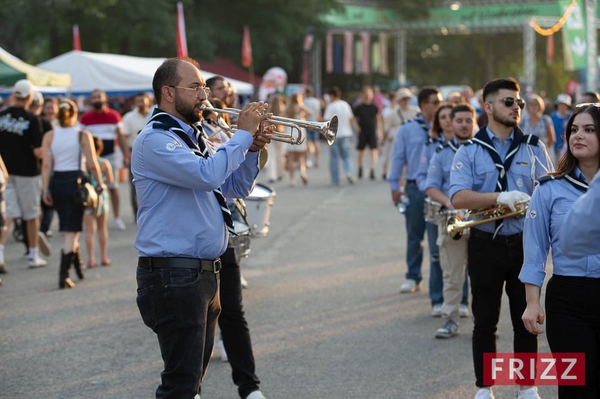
[42,100,106,288]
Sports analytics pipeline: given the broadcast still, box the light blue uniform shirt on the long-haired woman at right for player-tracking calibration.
[519,169,600,287]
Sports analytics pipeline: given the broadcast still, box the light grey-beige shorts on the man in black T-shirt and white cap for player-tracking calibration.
[4,175,42,221]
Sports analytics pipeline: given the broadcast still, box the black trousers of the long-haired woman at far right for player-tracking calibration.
[546,275,600,399]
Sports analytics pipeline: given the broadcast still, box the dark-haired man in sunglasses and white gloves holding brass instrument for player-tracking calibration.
[449,78,552,399]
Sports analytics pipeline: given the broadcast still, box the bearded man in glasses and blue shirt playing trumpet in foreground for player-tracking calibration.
[131,58,271,398]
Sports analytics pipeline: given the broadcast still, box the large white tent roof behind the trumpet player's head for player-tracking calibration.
[38,51,254,95]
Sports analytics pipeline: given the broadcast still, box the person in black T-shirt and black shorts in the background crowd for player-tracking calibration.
[354,86,383,180]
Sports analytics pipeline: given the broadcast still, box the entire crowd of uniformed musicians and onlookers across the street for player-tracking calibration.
[0,58,600,399]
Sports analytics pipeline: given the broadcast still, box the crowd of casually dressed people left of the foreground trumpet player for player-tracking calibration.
[0,80,143,288]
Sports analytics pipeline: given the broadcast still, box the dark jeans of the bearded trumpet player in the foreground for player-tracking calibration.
[137,267,221,399]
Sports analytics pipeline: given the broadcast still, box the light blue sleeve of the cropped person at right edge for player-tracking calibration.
[558,173,600,257]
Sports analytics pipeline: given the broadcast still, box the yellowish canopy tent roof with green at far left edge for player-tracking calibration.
[0,47,71,87]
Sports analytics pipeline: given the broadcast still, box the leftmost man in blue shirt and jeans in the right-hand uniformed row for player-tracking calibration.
[387,86,443,312]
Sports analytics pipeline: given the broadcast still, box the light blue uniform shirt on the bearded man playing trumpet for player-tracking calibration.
[131,117,259,259]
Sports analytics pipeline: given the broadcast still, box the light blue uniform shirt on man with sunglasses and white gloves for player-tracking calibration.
[449,128,552,235]
